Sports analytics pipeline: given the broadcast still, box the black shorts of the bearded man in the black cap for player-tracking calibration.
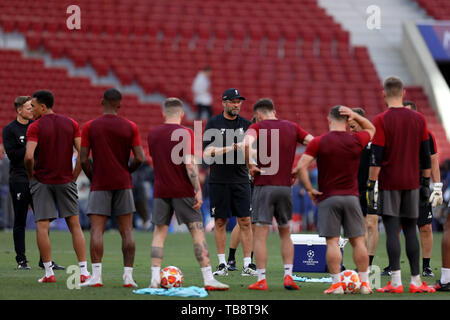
[209,183,252,219]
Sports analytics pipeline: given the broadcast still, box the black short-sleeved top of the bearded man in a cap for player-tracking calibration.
[203,113,251,183]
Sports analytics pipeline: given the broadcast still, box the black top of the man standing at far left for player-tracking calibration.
[3,119,33,183]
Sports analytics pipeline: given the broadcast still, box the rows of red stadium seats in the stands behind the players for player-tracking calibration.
[0,0,450,157]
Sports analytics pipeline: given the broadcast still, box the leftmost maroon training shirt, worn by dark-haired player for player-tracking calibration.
[27,113,80,184]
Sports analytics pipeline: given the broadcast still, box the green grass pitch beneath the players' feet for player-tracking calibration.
[0,230,450,301]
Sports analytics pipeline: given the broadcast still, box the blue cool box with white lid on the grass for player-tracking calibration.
[291,234,348,273]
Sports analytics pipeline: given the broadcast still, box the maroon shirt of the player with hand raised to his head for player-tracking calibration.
[305,131,370,202]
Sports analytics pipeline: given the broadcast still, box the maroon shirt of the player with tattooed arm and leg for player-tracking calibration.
[148,123,195,198]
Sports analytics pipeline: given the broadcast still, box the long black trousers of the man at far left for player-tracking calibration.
[9,182,33,263]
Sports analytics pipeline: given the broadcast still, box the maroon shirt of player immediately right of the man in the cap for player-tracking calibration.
[247,119,309,186]
